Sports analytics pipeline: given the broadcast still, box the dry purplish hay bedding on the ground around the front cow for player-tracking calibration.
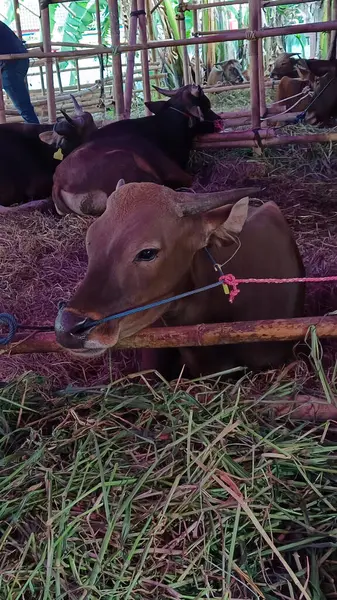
[0,146,337,386]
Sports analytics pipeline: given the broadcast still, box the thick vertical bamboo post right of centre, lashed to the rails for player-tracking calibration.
[249,0,260,129]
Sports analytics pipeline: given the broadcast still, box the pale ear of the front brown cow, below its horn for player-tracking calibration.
[204,197,249,243]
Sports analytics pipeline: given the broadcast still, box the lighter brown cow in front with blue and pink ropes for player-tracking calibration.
[55,182,304,376]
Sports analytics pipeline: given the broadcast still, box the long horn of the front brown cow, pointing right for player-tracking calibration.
[177,188,261,216]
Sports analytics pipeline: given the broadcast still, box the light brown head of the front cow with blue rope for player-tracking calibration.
[55,181,256,356]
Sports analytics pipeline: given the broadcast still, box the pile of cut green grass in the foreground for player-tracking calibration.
[0,370,337,600]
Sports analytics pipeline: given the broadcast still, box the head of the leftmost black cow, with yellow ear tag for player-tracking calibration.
[40,94,97,156]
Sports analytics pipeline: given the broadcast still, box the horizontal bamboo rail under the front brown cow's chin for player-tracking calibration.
[0,316,337,354]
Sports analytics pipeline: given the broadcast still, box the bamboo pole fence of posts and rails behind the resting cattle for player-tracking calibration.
[0,0,337,139]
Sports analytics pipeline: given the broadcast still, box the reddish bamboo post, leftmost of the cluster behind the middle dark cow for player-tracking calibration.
[108,0,124,119]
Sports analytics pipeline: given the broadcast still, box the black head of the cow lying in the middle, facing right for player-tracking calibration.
[145,84,220,133]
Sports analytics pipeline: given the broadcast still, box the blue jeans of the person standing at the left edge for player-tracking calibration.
[1,58,39,123]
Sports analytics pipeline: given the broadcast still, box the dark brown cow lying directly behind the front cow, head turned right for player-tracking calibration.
[53,85,219,215]
